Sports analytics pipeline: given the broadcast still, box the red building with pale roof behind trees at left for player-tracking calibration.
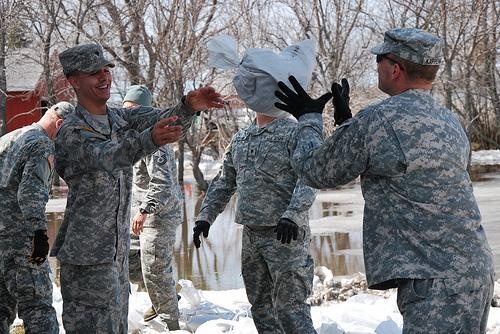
[6,49,74,132]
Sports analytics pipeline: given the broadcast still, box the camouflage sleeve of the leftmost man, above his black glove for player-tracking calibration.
[17,155,51,232]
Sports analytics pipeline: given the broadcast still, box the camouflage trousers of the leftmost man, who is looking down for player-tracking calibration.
[2,255,59,334]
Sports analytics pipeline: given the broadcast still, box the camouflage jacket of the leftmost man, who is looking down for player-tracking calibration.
[0,124,54,237]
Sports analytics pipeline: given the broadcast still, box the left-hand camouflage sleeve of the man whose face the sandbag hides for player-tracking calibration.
[197,145,236,224]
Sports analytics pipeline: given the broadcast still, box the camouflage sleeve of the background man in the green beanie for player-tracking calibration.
[140,147,177,213]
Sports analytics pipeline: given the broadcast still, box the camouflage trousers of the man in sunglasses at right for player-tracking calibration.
[397,275,494,334]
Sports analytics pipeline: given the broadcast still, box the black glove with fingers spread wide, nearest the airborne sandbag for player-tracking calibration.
[274,75,332,119]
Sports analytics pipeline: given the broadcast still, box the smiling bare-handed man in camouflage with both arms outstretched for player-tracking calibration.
[52,44,221,334]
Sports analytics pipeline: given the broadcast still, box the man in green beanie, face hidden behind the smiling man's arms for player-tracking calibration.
[123,85,183,330]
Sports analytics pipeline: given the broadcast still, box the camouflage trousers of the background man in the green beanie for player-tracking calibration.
[140,224,179,319]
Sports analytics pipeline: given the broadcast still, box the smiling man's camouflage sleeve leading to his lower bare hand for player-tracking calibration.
[55,124,157,178]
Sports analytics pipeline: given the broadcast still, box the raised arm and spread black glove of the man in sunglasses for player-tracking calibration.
[275,77,368,189]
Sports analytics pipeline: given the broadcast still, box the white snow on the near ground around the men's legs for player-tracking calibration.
[11,267,500,334]
